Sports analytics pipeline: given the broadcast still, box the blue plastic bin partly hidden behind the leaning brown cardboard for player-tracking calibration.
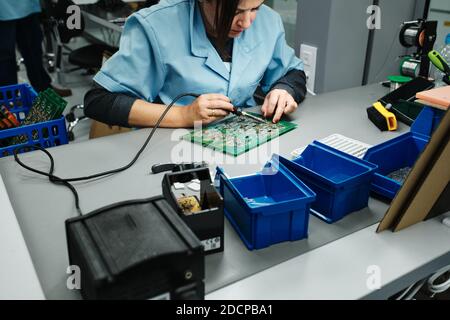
[364,107,444,199]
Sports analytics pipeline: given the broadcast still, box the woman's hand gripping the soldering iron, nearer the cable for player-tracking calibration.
[186,93,233,124]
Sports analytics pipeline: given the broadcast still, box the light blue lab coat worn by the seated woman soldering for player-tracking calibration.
[94,0,303,106]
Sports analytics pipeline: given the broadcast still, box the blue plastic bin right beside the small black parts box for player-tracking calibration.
[216,158,315,250]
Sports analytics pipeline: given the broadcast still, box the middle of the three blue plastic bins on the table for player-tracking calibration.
[280,141,377,223]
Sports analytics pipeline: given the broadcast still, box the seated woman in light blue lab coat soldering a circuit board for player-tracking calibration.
[85,0,306,127]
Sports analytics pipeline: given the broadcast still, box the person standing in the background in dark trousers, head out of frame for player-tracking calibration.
[0,0,71,97]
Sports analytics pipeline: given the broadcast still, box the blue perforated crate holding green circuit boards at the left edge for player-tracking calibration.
[0,84,69,158]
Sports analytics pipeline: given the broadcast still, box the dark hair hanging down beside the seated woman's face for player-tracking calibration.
[214,0,239,51]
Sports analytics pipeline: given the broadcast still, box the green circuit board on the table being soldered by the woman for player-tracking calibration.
[182,113,297,157]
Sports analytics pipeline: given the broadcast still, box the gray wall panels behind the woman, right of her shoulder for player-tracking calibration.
[295,0,428,93]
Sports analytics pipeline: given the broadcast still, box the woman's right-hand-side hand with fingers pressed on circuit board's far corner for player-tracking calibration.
[261,89,298,123]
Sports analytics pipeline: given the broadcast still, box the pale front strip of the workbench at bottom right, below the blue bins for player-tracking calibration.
[205,218,450,300]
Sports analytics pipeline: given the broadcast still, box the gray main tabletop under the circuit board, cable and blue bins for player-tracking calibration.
[0,84,440,299]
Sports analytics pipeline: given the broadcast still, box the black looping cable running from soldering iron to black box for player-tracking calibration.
[14,93,200,216]
